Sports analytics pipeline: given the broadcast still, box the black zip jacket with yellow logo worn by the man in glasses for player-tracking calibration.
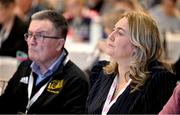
[0,60,88,114]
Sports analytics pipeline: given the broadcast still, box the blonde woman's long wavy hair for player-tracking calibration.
[103,12,171,92]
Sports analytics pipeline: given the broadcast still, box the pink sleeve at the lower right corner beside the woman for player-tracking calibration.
[159,84,180,114]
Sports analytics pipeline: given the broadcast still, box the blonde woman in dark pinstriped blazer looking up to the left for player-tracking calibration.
[86,12,176,114]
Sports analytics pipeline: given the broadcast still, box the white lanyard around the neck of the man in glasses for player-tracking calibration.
[25,72,48,113]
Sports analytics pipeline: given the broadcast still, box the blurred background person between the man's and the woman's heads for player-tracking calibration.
[64,0,92,42]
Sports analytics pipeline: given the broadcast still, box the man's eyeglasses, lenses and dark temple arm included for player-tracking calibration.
[24,33,62,41]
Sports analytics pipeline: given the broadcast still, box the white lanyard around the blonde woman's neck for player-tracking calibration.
[102,75,131,115]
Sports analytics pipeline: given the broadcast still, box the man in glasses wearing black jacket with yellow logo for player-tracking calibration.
[0,10,88,114]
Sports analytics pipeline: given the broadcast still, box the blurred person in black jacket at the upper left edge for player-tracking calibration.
[0,0,28,57]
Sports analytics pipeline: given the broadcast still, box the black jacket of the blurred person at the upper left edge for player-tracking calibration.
[0,16,28,57]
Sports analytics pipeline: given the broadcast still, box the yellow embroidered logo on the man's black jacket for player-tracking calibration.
[47,80,64,94]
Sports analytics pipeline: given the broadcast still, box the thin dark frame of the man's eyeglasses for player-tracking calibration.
[24,32,63,41]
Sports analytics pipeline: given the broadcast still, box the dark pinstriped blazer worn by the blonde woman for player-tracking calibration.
[86,61,176,114]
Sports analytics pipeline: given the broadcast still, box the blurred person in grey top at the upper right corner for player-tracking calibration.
[148,0,180,34]
